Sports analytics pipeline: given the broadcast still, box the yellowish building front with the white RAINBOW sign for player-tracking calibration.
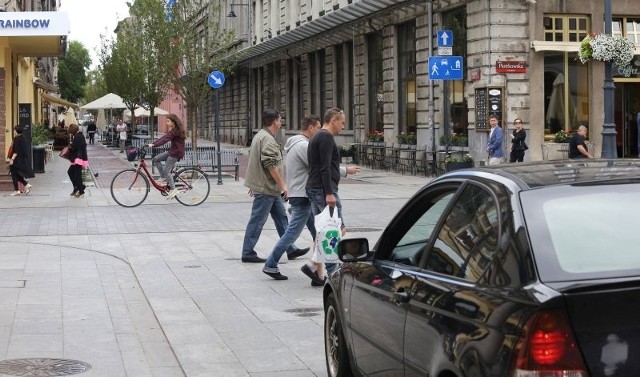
[0,0,70,187]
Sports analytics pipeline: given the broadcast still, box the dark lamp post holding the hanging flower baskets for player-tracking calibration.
[602,0,618,158]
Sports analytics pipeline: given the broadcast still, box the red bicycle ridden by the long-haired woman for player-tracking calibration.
[111,146,211,208]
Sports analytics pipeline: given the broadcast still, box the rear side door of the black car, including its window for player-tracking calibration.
[404,182,515,376]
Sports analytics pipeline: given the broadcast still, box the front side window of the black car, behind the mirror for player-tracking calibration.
[389,189,455,266]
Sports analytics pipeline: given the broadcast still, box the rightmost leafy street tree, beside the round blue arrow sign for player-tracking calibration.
[169,0,234,148]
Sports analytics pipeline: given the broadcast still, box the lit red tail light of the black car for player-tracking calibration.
[512,310,588,377]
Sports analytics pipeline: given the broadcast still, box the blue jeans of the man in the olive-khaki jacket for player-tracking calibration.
[242,192,298,258]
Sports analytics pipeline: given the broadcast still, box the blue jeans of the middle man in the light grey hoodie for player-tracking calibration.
[262,198,316,273]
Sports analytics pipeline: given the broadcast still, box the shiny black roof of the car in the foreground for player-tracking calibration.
[443,159,640,190]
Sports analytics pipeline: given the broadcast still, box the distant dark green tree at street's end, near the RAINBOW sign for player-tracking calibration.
[58,41,91,102]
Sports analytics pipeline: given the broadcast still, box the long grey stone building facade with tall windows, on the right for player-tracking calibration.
[206,0,640,161]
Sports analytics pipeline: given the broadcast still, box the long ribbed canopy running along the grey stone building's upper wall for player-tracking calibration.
[236,0,426,68]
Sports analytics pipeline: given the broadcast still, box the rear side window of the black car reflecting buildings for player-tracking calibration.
[425,184,499,282]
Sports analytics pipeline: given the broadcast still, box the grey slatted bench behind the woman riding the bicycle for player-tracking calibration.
[151,144,240,181]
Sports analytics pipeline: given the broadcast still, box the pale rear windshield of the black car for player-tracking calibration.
[520,182,640,282]
